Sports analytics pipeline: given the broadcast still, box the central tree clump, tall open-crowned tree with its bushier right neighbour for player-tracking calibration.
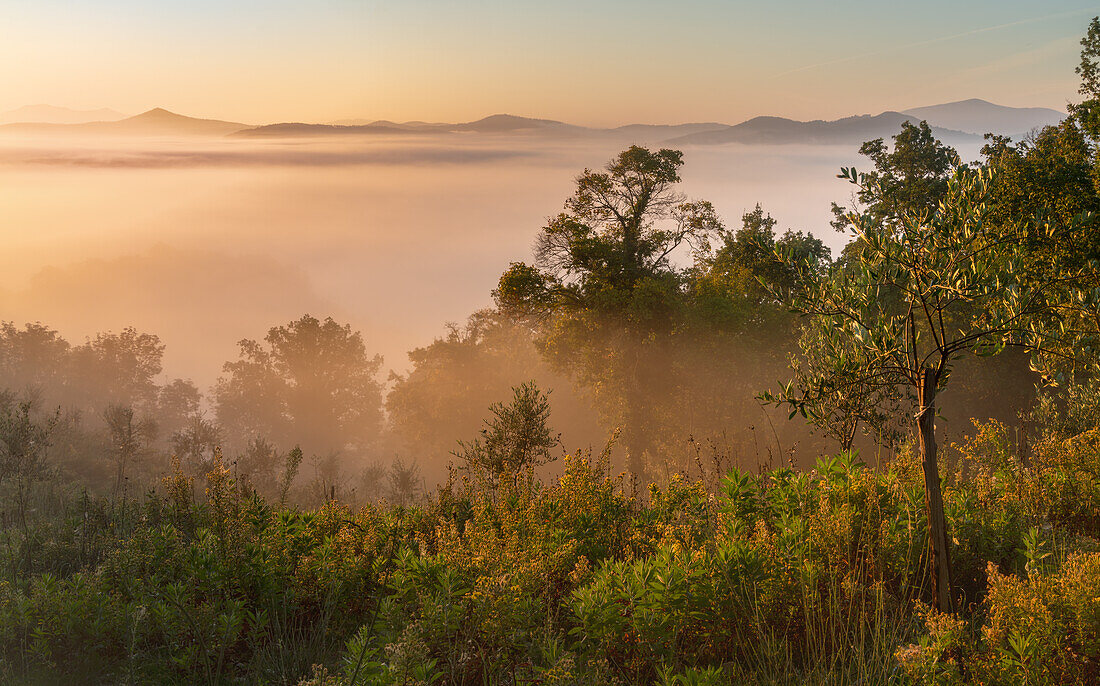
[494,146,828,477]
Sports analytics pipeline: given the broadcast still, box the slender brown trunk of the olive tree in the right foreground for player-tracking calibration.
[916,368,955,612]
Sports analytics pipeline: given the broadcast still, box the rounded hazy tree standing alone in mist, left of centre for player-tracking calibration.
[215,314,382,454]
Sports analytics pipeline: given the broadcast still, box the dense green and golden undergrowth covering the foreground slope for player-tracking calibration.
[0,415,1100,685]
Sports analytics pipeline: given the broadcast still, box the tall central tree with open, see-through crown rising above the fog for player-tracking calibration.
[494,146,723,476]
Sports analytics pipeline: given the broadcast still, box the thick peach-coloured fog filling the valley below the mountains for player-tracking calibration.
[0,133,978,387]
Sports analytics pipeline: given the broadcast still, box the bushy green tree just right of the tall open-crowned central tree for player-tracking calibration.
[668,204,829,466]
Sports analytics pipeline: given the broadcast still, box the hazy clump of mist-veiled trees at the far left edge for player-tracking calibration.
[0,322,201,493]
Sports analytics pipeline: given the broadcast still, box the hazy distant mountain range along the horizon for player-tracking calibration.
[0,99,1065,145]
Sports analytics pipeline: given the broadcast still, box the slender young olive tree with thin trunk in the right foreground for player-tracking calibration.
[772,167,1091,611]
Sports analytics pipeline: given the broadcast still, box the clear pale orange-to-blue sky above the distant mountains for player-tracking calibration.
[0,0,1100,125]
